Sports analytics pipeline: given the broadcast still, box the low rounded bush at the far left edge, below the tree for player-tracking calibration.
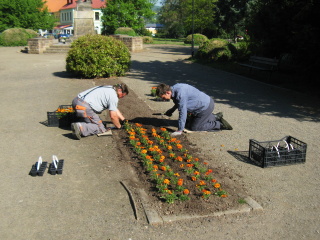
[0,28,38,46]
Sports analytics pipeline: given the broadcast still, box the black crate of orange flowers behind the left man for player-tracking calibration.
[47,105,76,128]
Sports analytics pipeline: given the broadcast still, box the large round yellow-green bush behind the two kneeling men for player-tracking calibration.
[66,35,130,78]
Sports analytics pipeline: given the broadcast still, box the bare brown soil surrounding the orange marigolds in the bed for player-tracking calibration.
[96,79,246,215]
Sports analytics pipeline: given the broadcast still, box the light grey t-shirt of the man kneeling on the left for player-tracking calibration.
[78,86,119,113]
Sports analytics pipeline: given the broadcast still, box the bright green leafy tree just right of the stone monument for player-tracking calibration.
[102,0,155,34]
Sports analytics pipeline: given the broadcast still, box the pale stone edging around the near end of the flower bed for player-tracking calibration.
[127,189,263,225]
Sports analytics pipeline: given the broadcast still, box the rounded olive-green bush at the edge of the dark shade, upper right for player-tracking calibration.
[195,39,236,61]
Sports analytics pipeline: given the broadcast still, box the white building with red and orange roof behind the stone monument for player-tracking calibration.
[46,0,106,35]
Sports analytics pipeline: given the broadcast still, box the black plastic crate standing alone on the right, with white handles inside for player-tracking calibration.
[249,136,307,168]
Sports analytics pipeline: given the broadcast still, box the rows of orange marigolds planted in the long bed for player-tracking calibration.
[124,122,228,203]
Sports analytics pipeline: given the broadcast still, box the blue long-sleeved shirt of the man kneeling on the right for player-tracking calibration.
[171,83,210,131]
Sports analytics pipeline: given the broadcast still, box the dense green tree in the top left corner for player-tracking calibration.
[0,0,55,32]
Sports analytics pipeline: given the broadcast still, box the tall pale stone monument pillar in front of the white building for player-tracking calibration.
[73,0,95,37]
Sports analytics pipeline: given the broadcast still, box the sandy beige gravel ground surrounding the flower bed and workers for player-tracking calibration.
[0,46,320,240]
